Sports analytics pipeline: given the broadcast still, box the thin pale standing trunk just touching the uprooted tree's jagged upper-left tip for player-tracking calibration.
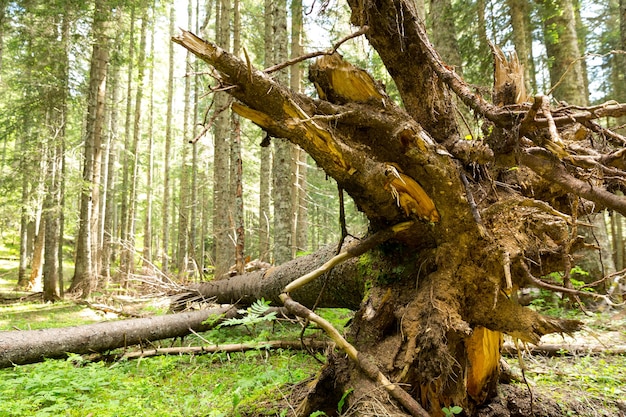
[161,2,176,273]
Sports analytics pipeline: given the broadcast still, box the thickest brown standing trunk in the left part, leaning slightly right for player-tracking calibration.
[70,0,109,298]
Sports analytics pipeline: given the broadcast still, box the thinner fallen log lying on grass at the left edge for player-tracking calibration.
[0,307,237,368]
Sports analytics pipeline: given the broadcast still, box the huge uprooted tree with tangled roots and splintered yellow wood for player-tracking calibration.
[169,0,626,415]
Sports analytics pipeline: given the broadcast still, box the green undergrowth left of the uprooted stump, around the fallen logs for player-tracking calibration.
[0,270,344,417]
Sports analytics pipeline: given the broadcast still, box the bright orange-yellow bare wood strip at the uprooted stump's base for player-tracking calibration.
[466,327,502,403]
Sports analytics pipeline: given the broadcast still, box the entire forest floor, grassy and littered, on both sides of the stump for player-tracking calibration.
[0,260,626,417]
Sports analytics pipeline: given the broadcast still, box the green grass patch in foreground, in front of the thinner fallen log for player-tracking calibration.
[0,350,319,417]
